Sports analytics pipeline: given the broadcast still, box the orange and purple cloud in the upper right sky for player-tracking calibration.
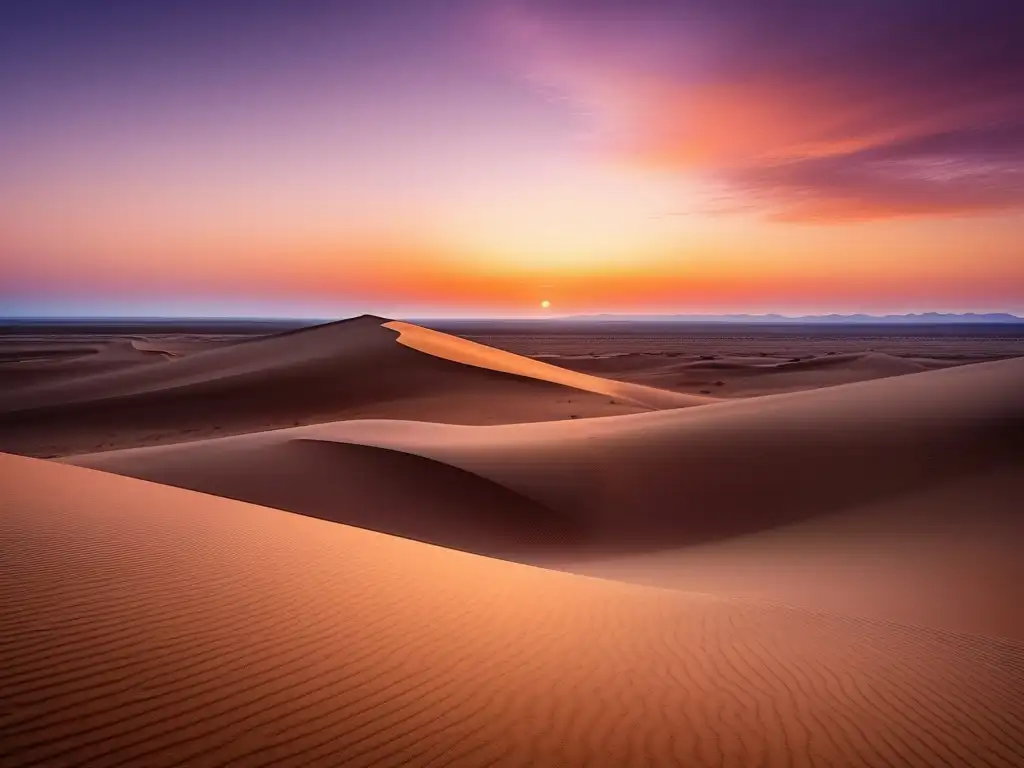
[502,0,1024,219]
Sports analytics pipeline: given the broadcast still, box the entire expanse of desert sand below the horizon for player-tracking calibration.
[0,316,1024,768]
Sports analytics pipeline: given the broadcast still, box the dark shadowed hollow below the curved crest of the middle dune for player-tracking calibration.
[71,430,583,557]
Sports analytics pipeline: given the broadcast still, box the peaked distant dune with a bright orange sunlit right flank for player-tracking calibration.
[0,316,688,456]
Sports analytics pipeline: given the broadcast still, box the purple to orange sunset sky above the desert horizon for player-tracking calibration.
[0,0,1024,317]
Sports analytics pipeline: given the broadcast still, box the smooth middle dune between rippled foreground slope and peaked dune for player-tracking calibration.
[71,358,1024,638]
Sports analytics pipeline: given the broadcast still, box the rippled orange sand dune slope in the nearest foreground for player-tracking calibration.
[0,456,1024,768]
